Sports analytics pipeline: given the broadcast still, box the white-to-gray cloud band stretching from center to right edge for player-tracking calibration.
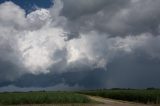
[67,32,160,68]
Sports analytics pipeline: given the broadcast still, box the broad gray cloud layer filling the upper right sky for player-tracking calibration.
[62,0,160,38]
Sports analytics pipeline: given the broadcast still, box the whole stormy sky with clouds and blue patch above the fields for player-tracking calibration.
[0,0,160,92]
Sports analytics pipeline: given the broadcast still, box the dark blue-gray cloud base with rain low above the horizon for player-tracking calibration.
[0,55,160,89]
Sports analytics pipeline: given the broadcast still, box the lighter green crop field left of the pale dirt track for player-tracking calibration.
[0,92,91,105]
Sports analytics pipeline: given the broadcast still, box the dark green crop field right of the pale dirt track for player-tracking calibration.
[79,90,160,104]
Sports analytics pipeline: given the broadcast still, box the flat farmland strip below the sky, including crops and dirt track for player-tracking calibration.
[0,90,160,106]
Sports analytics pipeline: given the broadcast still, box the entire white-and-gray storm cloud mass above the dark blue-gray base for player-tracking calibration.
[0,0,160,88]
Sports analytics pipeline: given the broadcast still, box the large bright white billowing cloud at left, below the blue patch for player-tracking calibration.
[0,2,65,74]
